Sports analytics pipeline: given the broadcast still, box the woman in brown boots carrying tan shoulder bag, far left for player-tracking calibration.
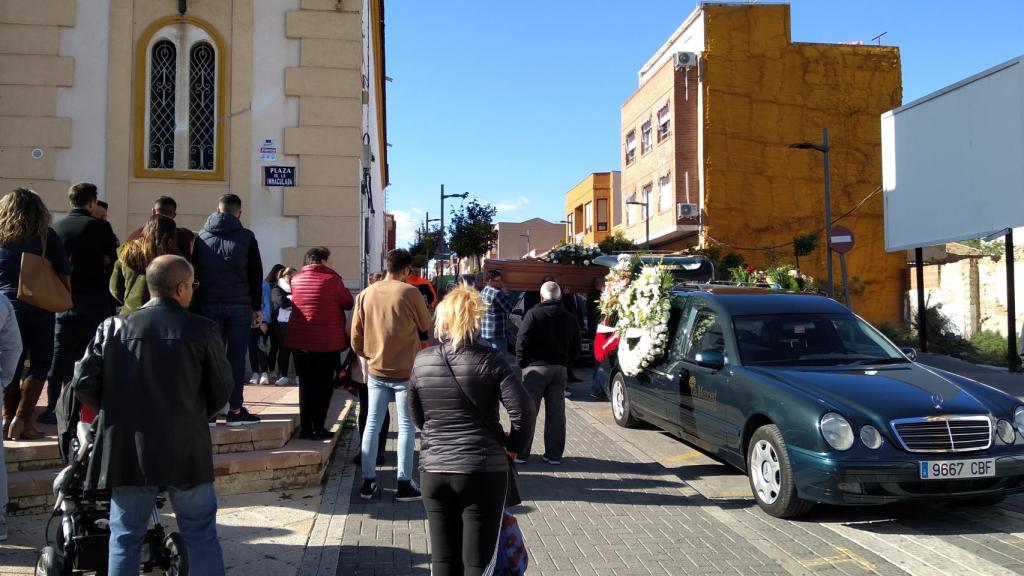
[0,188,71,440]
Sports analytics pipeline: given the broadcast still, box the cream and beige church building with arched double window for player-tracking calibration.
[0,0,388,287]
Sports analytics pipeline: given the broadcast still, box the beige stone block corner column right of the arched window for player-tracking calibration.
[284,0,362,285]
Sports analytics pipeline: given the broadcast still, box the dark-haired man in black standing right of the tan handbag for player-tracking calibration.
[39,182,118,424]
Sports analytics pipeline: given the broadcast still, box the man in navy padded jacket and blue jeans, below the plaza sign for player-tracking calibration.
[193,194,263,426]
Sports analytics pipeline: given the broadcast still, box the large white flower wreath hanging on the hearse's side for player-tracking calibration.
[602,257,674,376]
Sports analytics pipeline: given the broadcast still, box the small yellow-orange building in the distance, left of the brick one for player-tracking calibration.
[564,170,622,244]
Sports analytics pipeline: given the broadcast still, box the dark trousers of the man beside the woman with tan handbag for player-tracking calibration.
[46,305,114,412]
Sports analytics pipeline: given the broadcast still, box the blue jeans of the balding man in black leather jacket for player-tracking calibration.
[108,482,224,576]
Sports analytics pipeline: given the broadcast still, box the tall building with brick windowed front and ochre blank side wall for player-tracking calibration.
[620,4,905,321]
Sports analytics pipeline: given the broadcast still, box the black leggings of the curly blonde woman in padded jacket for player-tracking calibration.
[420,471,508,576]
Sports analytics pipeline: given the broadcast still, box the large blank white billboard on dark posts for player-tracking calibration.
[882,56,1024,252]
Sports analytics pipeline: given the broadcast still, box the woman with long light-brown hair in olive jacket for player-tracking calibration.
[111,214,184,316]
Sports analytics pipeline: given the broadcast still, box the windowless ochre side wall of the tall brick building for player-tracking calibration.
[700,4,906,322]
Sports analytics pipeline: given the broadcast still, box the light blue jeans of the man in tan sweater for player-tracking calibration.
[359,375,416,480]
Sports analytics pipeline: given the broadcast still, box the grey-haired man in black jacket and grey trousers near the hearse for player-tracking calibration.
[515,282,580,465]
